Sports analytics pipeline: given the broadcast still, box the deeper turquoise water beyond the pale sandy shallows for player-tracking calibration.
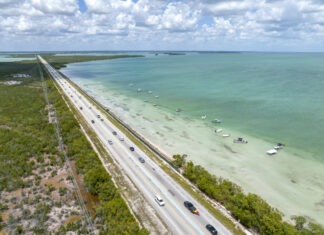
[63,53,324,162]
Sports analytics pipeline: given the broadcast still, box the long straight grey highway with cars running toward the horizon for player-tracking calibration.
[38,56,232,235]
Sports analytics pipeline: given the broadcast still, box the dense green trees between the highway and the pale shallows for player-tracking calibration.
[174,155,324,235]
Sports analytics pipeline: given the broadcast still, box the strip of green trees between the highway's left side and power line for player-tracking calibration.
[48,76,148,235]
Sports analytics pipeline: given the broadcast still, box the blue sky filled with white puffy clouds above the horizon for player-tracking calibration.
[0,0,324,52]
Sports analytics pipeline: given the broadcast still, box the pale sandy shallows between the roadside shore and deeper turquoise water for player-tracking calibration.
[60,76,324,226]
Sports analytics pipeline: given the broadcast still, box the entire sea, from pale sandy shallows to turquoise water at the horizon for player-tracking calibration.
[61,52,324,223]
